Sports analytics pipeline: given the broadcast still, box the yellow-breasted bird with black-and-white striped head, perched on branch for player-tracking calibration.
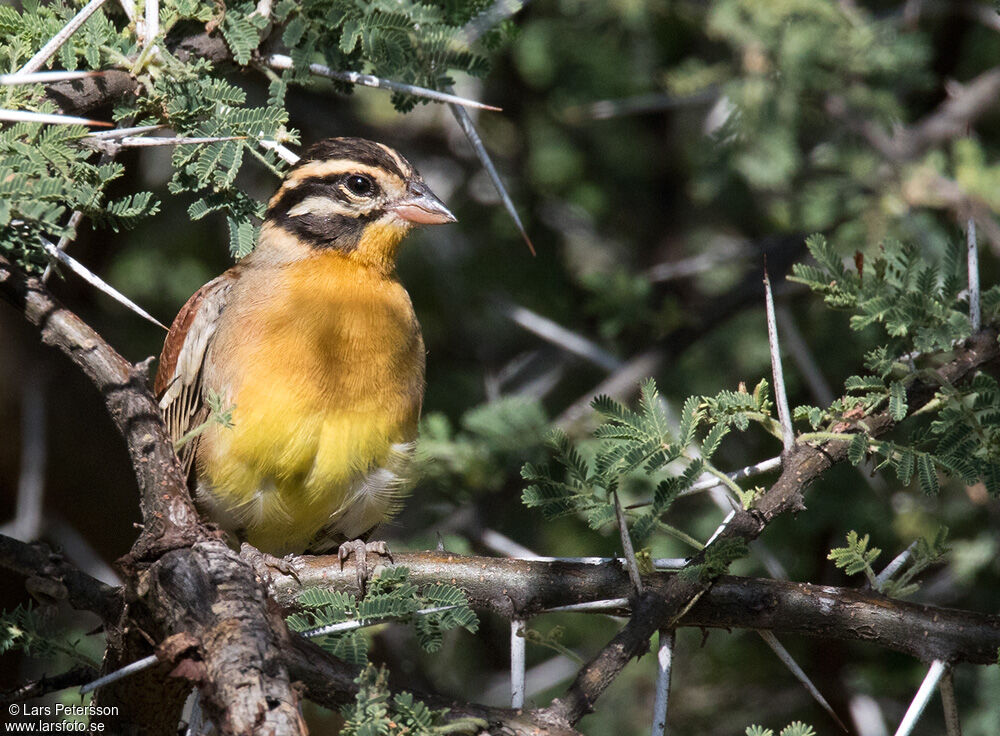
[154,137,456,589]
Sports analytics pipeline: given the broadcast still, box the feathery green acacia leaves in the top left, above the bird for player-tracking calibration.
[0,0,501,270]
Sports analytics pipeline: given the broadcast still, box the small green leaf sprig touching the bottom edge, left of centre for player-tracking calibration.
[340,664,488,736]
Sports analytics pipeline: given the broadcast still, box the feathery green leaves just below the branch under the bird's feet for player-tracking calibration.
[287,567,479,664]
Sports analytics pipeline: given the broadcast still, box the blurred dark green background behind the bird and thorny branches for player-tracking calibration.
[0,0,1000,736]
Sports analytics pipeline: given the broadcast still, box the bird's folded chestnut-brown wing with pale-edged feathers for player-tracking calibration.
[153,266,239,474]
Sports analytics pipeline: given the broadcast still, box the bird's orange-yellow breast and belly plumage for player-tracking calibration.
[198,251,424,552]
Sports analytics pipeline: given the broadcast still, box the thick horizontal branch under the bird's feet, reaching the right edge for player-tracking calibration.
[272,552,1000,664]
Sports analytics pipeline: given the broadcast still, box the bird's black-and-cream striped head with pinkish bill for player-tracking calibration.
[261,138,456,265]
